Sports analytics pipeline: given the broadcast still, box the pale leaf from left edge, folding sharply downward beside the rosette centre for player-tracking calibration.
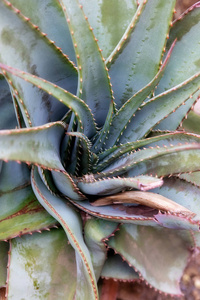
[0,122,84,200]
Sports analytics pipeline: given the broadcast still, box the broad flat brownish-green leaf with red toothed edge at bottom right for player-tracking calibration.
[108,224,194,296]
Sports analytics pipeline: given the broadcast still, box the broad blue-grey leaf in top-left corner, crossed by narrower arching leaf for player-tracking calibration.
[0,0,77,126]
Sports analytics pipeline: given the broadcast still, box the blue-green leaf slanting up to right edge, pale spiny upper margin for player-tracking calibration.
[119,73,200,143]
